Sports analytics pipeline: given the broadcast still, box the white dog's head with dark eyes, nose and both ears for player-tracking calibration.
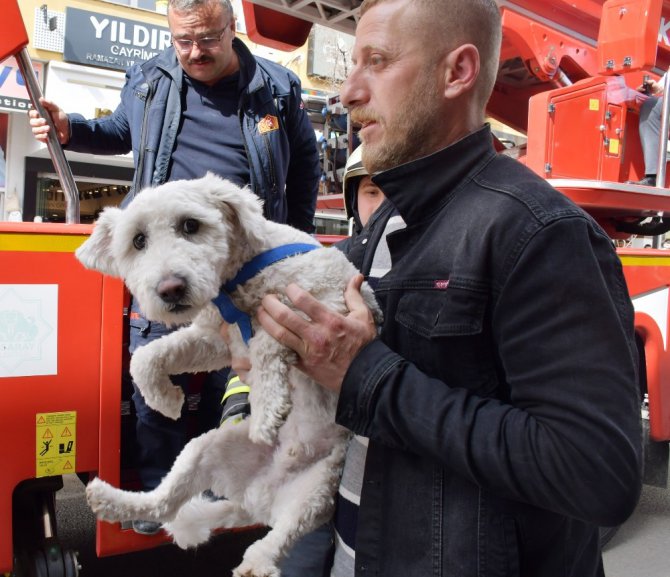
[76,174,263,325]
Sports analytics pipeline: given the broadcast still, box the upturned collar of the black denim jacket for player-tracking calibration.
[372,124,496,226]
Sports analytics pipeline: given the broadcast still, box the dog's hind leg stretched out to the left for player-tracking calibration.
[86,429,220,522]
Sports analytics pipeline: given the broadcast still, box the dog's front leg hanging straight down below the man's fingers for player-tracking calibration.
[243,330,297,445]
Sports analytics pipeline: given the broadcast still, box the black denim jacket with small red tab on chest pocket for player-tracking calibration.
[337,128,641,577]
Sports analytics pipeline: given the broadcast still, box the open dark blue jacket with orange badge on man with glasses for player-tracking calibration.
[67,38,320,232]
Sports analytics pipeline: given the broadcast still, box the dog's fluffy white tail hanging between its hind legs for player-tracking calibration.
[163,497,255,549]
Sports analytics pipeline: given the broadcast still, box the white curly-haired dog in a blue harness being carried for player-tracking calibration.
[76,174,381,577]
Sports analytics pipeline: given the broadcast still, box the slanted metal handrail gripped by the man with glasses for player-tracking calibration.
[14,47,80,224]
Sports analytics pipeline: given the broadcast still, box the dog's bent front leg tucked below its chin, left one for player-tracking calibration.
[130,307,230,419]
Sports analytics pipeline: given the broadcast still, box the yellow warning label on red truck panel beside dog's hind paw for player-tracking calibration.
[35,411,77,477]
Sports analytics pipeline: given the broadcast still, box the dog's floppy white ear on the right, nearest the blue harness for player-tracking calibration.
[203,172,263,245]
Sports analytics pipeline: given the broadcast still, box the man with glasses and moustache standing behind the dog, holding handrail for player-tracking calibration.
[30,0,320,534]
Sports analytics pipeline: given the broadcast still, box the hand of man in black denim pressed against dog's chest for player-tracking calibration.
[258,275,377,391]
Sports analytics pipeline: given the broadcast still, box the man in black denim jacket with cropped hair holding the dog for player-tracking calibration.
[259,0,641,577]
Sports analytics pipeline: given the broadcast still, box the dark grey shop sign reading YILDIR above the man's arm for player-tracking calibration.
[63,8,170,70]
